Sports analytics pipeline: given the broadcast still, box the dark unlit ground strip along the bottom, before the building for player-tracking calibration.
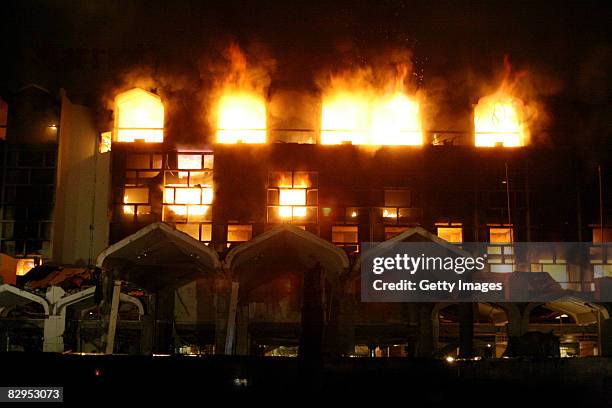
[0,353,612,407]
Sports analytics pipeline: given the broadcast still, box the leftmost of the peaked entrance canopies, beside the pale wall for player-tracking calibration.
[96,222,221,291]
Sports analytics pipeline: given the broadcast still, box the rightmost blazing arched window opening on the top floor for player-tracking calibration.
[474,90,528,147]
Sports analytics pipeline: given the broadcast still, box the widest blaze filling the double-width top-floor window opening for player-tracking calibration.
[321,70,423,146]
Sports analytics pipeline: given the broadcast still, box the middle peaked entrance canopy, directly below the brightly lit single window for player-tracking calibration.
[225,224,349,288]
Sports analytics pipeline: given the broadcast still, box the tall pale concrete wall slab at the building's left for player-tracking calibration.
[52,93,110,265]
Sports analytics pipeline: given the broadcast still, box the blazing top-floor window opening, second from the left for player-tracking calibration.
[217,91,266,143]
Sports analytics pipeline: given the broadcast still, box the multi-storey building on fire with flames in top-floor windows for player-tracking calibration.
[0,54,612,357]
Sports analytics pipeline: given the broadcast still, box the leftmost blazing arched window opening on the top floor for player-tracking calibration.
[114,88,164,143]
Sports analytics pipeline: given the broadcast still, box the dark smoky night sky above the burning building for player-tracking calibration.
[0,0,612,143]
